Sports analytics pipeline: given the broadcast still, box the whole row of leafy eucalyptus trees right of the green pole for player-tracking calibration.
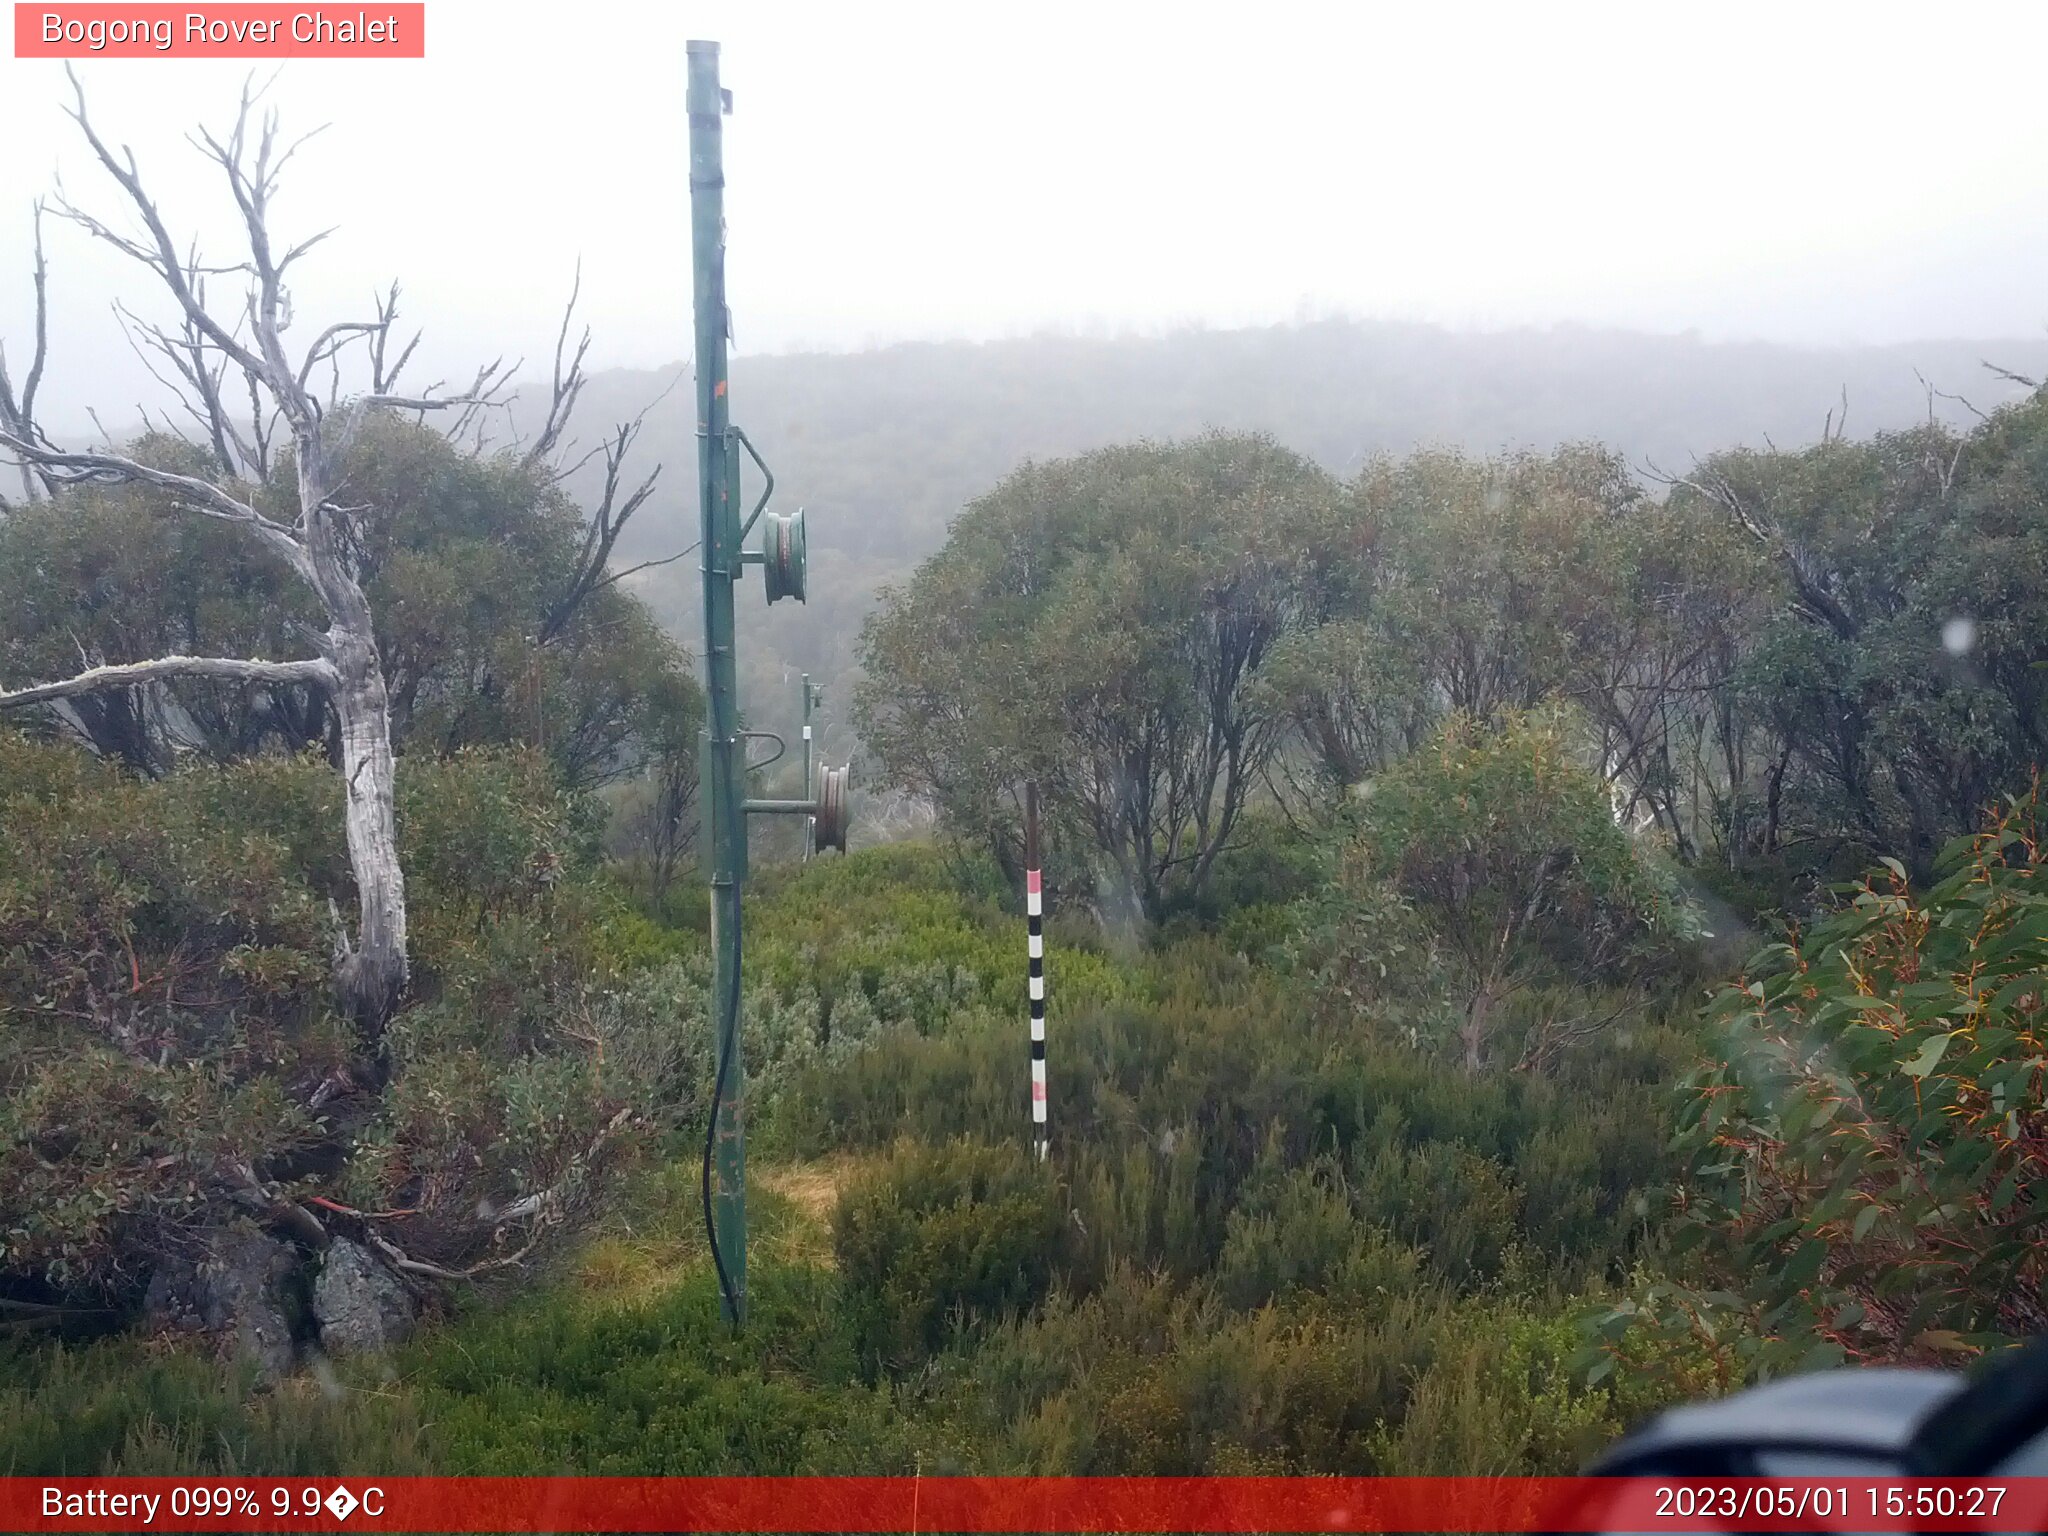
[858,395,2048,918]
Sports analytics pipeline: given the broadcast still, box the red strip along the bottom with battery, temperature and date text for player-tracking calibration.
[0,1477,2048,1532]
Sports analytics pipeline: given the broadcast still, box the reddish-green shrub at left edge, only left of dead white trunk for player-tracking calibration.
[0,731,352,1292]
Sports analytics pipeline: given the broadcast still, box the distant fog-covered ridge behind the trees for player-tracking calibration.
[540,322,2048,745]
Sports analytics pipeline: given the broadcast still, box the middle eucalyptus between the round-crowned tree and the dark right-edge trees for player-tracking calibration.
[1268,444,1757,854]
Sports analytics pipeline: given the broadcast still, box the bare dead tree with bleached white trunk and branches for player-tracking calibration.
[0,74,508,1044]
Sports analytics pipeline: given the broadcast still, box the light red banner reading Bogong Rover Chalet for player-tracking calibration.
[14,0,426,59]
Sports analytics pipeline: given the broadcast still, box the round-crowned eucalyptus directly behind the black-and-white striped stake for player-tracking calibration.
[856,434,1335,918]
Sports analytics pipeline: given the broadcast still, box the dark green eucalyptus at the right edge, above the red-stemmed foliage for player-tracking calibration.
[1671,395,2048,874]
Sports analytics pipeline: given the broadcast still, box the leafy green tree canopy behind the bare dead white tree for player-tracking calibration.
[0,412,698,786]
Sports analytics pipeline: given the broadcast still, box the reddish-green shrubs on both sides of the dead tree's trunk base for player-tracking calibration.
[0,731,668,1300]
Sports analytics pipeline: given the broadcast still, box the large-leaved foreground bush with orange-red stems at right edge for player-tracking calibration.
[1604,784,2048,1374]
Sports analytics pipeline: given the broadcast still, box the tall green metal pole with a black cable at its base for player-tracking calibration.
[688,41,748,1329]
